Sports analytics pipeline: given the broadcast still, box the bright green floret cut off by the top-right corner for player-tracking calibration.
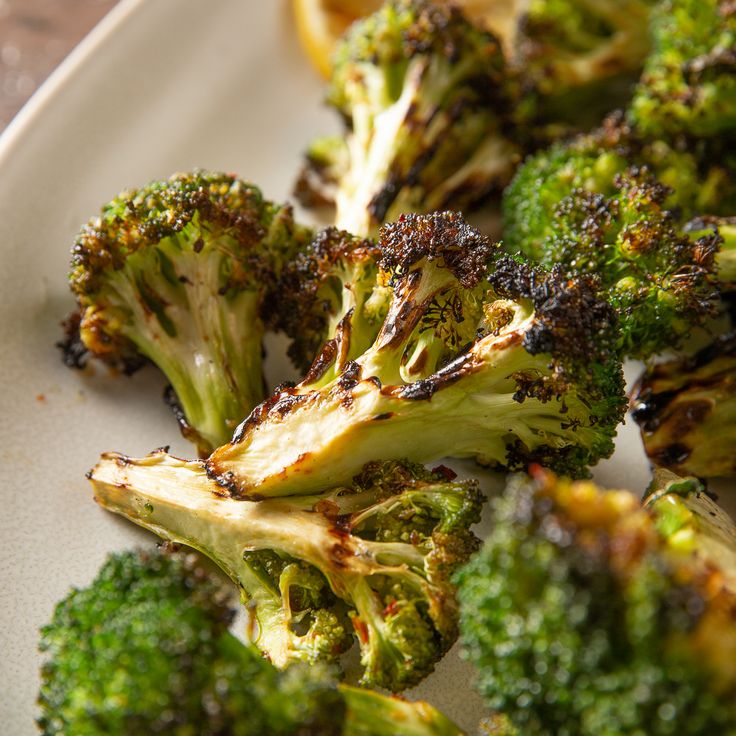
[629,0,736,140]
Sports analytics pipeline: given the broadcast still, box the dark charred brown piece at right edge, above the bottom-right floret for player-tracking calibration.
[632,332,736,478]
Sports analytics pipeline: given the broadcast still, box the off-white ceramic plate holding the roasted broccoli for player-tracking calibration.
[0,0,716,736]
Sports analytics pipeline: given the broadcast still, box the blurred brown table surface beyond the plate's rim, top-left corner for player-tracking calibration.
[0,0,118,131]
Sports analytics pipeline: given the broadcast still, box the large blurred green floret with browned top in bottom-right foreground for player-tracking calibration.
[457,470,736,736]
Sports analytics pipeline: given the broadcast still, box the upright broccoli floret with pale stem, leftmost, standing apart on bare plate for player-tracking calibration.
[70,171,311,454]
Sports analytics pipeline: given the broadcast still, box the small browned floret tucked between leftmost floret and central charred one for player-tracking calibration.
[275,227,388,372]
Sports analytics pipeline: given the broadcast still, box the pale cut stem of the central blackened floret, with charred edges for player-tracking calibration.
[208,335,596,496]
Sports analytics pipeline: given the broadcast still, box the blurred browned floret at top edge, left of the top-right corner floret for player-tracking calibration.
[511,0,654,135]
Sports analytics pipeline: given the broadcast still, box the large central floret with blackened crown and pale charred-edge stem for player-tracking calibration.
[206,213,625,498]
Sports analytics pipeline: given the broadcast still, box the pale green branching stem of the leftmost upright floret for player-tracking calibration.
[100,237,265,454]
